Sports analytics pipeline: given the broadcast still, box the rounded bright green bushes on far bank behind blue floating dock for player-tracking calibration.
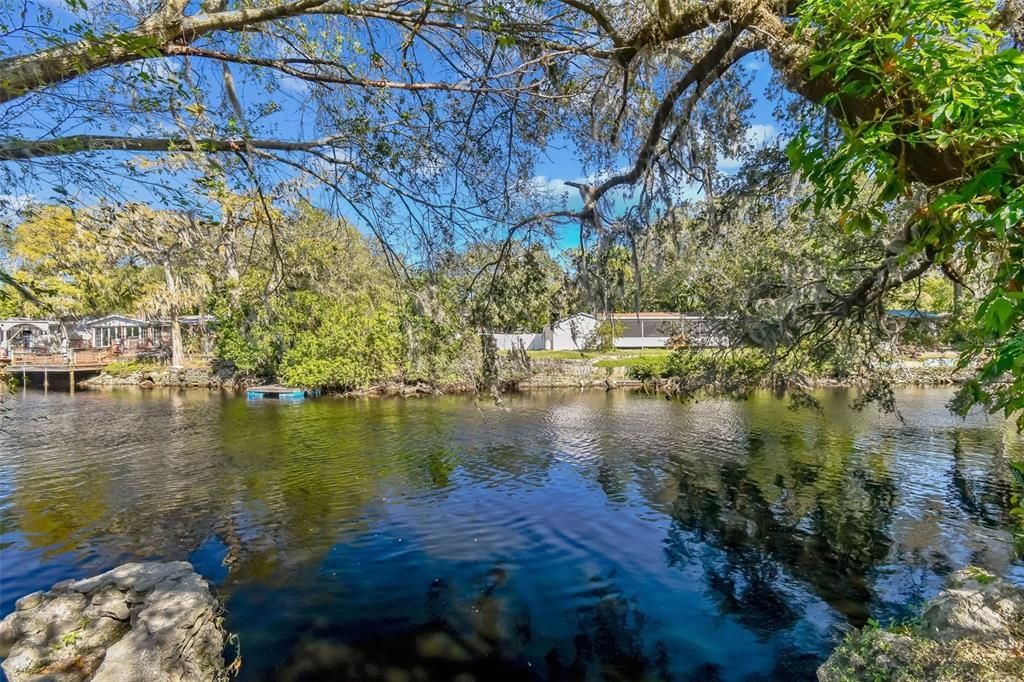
[213,206,479,388]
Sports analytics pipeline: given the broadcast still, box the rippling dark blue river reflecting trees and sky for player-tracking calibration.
[0,389,1024,682]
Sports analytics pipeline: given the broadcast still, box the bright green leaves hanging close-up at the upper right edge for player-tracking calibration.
[788,0,1024,419]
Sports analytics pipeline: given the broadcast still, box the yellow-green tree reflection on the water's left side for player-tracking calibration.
[3,394,479,583]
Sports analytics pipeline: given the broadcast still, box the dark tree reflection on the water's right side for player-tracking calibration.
[667,425,896,626]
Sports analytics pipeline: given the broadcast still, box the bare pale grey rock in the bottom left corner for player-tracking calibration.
[0,561,227,682]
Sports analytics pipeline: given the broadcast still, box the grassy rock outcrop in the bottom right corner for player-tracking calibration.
[818,568,1024,682]
